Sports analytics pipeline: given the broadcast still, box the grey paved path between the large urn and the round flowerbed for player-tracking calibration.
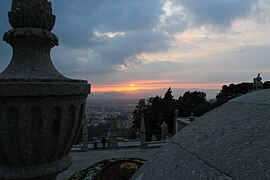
[57,148,159,180]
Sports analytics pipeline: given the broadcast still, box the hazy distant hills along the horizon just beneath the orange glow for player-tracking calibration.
[88,88,220,99]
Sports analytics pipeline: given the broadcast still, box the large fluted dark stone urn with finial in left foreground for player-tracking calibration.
[0,0,90,180]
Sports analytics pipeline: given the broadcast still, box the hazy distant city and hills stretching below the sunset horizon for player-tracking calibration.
[85,89,218,136]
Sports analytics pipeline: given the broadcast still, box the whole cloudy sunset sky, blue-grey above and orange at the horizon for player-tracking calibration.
[0,0,270,92]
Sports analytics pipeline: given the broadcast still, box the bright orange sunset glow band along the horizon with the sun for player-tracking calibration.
[92,81,224,93]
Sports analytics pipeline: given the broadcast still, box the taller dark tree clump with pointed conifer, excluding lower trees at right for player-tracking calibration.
[133,88,208,141]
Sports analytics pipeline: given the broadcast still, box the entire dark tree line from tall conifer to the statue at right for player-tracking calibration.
[133,81,270,141]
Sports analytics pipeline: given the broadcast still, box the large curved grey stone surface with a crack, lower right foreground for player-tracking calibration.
[133,90,270,180]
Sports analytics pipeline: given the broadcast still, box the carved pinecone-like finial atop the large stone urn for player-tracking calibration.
[8,0,55,31]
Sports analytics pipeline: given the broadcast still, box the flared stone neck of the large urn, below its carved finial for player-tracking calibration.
[0,28,62,81]
